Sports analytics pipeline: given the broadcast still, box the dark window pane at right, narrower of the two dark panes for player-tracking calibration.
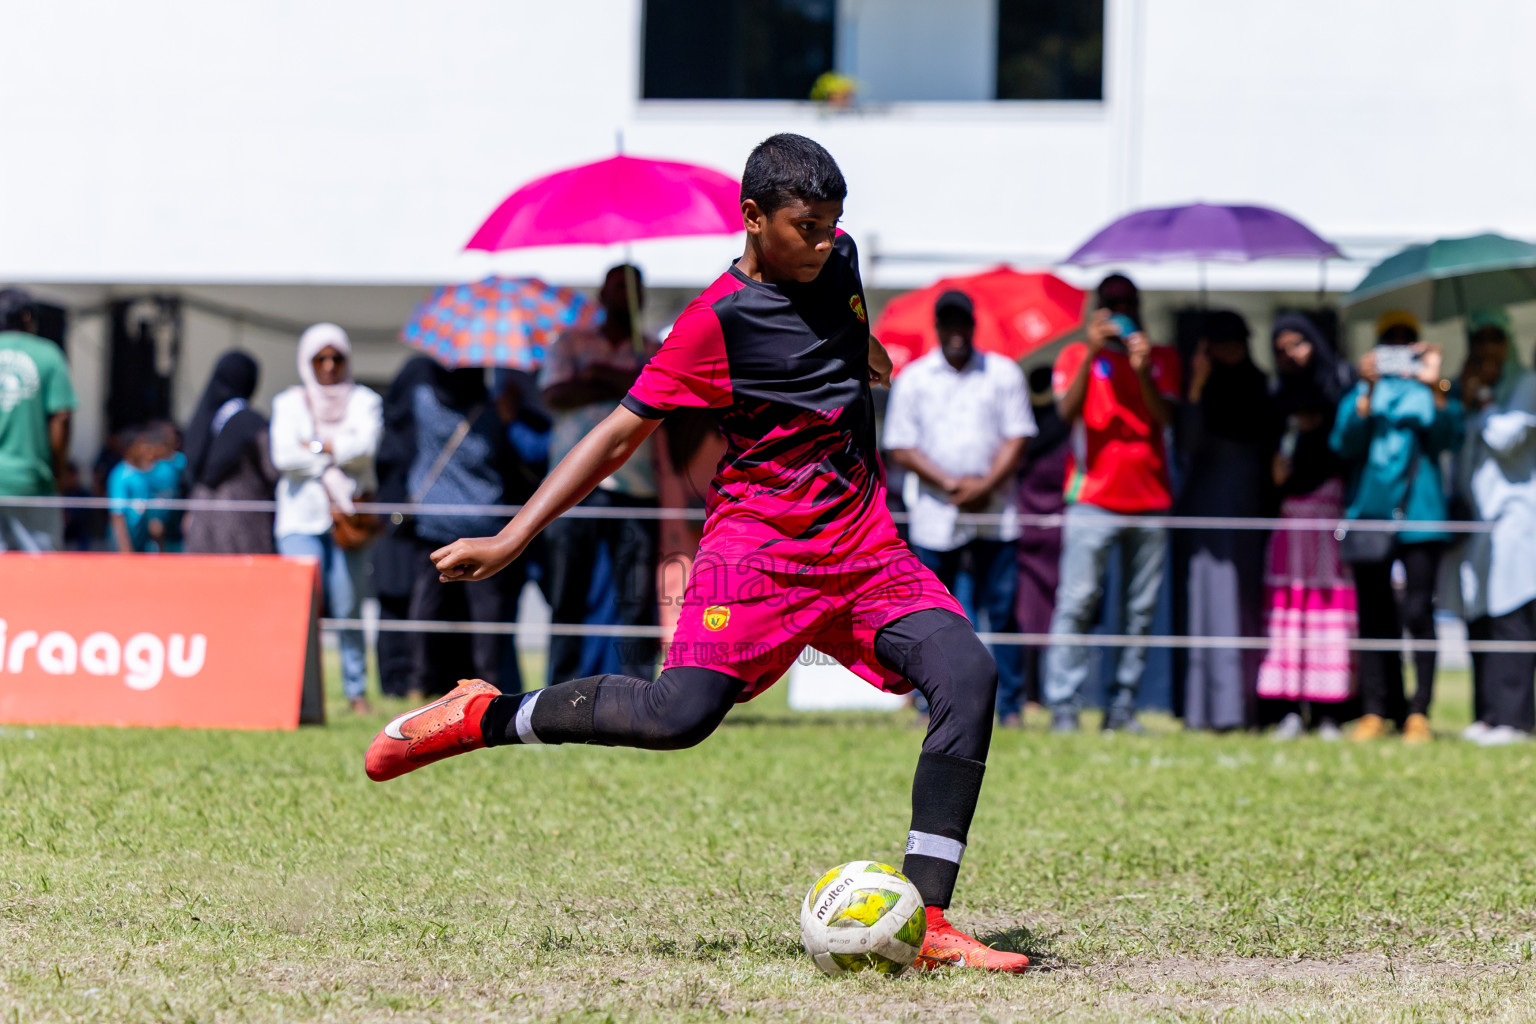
[997,0,1104,100]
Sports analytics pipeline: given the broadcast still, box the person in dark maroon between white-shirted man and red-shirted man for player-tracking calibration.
[997,367,1071,726]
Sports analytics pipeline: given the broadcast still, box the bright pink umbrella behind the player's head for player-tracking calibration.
[465,157,742,252]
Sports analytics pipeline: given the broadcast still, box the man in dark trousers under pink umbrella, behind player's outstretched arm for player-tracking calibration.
[539,266,657,683]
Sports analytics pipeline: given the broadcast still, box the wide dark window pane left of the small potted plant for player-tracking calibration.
[642,0,837,100]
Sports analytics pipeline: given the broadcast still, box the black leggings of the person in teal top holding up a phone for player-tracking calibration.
[1355,542,1444,725]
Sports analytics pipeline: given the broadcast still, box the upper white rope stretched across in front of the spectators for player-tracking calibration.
[0,496,1495,534]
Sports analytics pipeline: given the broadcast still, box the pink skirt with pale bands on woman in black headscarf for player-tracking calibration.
[1258,481,1359,703]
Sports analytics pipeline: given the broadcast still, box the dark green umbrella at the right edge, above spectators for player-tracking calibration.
[1344,235,1536,321]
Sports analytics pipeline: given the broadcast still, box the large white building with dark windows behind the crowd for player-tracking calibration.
[0,0,1536,457]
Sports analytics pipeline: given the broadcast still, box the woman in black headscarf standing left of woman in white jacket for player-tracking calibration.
[183,352,278,554]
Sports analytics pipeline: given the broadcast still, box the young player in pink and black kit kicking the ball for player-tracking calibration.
[367,135,1029,972]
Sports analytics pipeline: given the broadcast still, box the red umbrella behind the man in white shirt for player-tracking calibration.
[874,267,1087,370]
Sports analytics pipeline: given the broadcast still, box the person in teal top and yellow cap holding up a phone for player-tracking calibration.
[1330,310,1462,743]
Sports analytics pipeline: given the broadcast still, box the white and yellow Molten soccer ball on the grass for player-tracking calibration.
[800,860,928,978]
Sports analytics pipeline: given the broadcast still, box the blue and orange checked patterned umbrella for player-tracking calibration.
[399,278,598,372]
